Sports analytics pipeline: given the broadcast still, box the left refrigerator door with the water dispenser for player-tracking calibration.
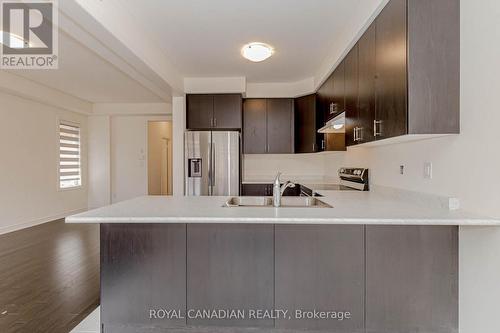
[185,131,211,196]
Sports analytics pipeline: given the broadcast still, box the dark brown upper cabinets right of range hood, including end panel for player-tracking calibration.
[344,0,460,145]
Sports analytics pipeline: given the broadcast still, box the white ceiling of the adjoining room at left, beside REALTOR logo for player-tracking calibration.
[10,31,162,103]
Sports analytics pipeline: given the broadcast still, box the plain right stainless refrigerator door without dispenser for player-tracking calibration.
[211,131,240,195]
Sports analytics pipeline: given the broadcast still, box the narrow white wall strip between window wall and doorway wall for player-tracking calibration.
[88,116,111,209]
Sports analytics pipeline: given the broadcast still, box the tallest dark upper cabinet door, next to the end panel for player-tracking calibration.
[375,0,408,139]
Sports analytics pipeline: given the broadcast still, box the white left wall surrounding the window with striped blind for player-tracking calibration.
[0,89,87,233]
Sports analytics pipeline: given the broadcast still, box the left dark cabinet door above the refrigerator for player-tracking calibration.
[186,95,214,130]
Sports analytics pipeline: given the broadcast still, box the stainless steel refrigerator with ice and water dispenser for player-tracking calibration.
[184,131,240,196]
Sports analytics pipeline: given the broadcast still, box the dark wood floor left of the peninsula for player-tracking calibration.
[0,220,99,333]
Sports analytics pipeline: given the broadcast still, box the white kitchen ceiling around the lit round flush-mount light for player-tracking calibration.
[120,0,383,82]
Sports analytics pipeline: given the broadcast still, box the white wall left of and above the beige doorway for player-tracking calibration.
[111,116,171,202]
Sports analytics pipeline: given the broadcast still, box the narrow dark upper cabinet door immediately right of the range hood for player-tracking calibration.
[344,45,359,146]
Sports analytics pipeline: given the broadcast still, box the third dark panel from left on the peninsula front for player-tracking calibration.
[275,225,364,333]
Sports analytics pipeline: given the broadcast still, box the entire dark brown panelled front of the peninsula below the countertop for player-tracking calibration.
[101,223,458,333]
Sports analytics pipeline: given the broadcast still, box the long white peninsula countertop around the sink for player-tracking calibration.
[66,189,500,226]
